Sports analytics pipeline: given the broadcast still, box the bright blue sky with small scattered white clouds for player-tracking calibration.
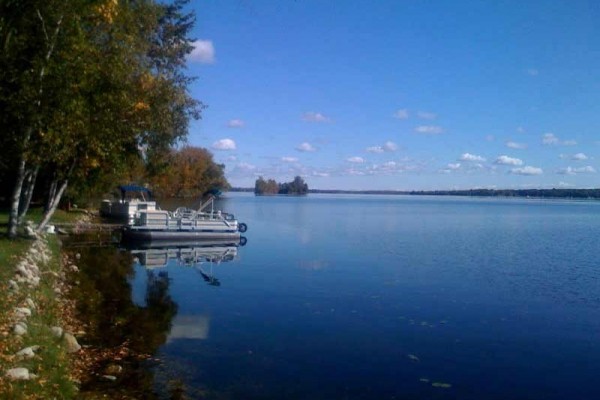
[188,0,600,190]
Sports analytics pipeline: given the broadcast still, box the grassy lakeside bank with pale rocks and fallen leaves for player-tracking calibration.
[0,213,146,399]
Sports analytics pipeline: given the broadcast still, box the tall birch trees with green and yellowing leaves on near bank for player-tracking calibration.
[0,0,228,237]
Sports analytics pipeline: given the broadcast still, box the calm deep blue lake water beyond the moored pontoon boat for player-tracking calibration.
[127,194,600,399]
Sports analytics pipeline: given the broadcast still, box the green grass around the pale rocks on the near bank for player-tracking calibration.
[0,210,79,399]
